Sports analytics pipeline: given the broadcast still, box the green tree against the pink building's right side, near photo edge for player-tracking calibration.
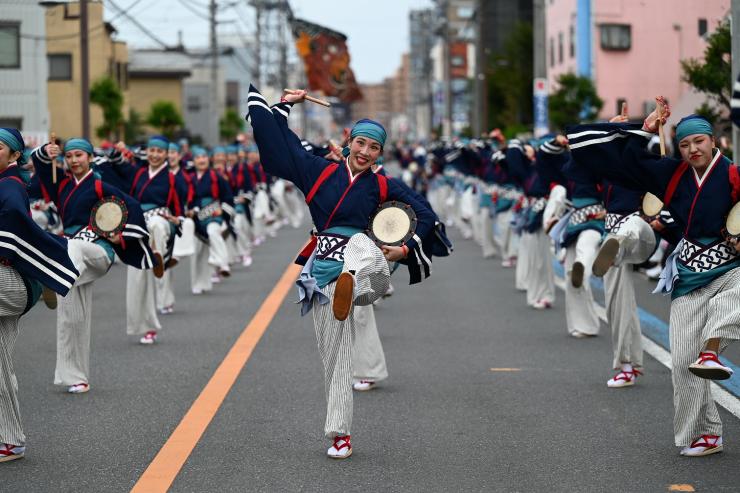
[681,20,732,127]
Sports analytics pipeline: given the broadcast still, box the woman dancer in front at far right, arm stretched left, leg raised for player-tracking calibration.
[569,97,740,457]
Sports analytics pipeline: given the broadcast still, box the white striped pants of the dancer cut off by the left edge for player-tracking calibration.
[0,265,28,445]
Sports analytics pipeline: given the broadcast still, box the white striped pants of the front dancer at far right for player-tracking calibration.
[670,268,740,447]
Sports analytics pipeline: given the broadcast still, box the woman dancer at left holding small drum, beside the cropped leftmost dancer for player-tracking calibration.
[31,139,154,394]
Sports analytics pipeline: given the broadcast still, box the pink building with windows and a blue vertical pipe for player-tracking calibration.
[546,0,731,121]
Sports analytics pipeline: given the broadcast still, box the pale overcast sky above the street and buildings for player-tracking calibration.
[104,0,432,83]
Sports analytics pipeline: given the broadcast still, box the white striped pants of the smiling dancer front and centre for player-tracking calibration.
[312,233,390,438]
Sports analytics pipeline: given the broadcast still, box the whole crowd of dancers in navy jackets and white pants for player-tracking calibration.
[0,87,740,461]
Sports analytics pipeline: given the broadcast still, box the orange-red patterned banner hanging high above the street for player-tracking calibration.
[291,19,362,103]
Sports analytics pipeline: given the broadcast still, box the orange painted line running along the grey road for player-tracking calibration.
[131,264,301,493]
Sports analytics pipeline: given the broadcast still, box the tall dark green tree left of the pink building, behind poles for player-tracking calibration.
[486,22,534,132]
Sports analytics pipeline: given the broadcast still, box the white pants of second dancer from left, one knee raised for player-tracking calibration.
[54,240,111,385]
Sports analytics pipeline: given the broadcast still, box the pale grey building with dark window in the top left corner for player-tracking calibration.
[0,2,49,145]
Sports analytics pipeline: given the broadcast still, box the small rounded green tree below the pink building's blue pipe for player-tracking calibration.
[548,73,604,130]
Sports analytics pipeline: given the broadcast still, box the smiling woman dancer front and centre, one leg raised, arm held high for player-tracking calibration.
[248,87,434,459]
